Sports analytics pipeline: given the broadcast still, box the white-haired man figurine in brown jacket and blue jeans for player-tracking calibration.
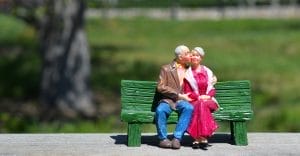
[155,45,193,149]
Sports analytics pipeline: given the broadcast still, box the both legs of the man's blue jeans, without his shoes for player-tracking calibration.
[155,100,194,140]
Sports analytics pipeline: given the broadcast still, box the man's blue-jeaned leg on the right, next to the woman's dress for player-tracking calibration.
[174,100,194,141]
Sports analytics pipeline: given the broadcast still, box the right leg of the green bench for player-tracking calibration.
[230,121,248,146]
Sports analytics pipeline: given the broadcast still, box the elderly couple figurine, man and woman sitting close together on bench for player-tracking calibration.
[155,45,219,150]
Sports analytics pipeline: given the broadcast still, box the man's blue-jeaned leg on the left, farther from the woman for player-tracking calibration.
[155,102,172,140]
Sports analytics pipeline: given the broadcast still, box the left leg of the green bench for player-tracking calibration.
[127,123,141,147]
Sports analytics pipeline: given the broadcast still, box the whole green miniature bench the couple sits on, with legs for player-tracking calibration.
[121,80,253,146]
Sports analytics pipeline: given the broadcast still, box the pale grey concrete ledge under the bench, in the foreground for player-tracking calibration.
[0,133,300,156]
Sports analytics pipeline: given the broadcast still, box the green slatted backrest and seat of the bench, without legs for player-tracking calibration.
[121,80,253,122]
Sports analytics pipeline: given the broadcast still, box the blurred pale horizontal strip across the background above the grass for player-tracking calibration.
[86,6,300,20]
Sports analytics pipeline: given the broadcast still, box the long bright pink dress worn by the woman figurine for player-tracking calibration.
[183,67,218,139]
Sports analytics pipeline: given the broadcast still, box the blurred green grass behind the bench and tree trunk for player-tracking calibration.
[0,13,300,132]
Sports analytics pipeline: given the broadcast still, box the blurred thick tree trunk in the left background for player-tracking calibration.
[40,0,96,118]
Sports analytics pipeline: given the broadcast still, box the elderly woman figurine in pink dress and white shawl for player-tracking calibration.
[183,47,219,150]
